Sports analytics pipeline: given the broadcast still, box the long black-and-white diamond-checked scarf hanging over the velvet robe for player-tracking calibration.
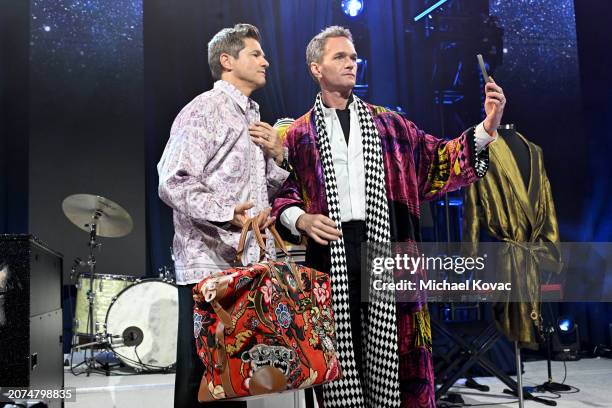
[314,94,400,408]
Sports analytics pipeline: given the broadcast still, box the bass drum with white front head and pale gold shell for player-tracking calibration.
[74,273,178,372]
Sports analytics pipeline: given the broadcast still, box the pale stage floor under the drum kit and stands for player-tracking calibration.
[64,358,612,408]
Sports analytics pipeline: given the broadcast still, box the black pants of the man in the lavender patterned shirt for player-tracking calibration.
[174,285,247,408]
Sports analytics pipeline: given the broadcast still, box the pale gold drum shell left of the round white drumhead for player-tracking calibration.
[73,273,136,336]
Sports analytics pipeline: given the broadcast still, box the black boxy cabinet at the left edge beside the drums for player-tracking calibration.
[0,235,64,406]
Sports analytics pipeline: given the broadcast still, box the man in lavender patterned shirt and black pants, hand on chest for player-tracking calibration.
[157,24,288,407]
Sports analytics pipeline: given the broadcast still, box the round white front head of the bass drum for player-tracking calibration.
[106,279,178,371]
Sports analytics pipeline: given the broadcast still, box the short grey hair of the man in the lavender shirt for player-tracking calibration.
[208,24,261,80]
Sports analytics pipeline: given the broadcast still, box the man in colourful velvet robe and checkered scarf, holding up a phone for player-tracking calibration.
[272,26,506,408]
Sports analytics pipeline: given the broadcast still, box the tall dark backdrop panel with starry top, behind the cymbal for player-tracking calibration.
[29,0,146,282]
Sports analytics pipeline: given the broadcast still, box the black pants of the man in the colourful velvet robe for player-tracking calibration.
[306,221,368,406]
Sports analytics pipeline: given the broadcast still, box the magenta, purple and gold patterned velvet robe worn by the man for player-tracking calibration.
[272,105,488,408]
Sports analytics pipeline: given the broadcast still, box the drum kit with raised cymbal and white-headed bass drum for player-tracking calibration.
[62,194,178,376]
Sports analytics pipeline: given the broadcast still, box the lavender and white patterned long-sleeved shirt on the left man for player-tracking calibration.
[157,81,289,285]
